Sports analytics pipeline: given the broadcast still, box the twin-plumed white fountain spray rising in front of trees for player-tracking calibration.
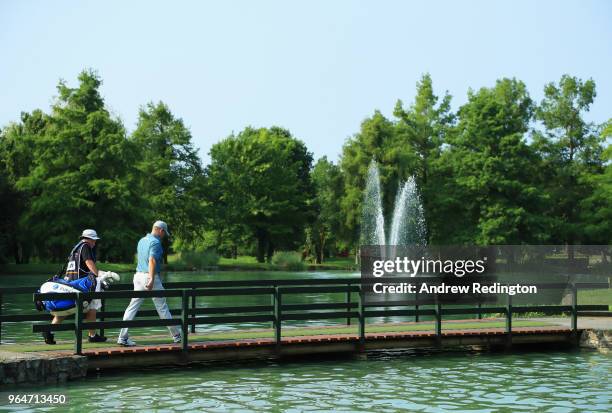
[361,160,427,248]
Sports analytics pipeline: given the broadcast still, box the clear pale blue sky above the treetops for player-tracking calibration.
[0,0,612,162]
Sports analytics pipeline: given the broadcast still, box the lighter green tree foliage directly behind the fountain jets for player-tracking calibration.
[340,74,454,248]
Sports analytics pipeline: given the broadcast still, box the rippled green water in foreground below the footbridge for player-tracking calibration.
[6,351,612,412]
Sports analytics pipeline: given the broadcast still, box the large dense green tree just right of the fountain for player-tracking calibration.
[436,79,543,245]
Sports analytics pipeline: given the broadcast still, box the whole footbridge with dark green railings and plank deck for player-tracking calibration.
[0,277,609,369]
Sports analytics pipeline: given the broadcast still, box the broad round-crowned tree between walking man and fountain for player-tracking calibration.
[206,127,314,262]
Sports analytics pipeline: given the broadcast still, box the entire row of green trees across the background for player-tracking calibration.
[0,70,612,263]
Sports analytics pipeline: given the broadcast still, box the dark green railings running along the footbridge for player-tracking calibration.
[0,277,609,354]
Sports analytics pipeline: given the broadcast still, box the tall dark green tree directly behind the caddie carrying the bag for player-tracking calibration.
[12,71,140,260]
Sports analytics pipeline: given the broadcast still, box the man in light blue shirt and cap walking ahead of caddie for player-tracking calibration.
[117,221,181,346]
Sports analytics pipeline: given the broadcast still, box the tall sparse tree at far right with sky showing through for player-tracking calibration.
[534,75,601,254]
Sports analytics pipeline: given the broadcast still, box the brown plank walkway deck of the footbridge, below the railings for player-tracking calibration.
[74,326,581,369]
